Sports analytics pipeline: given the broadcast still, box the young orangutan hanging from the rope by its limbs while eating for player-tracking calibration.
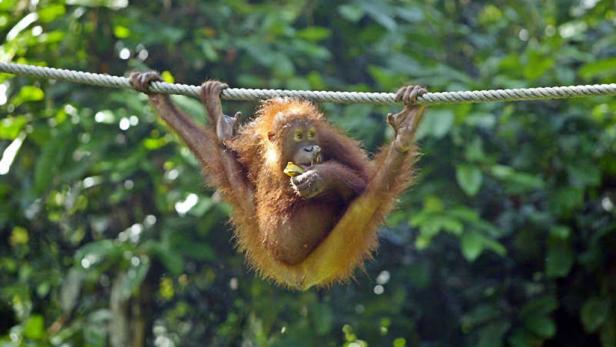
[130,72,426,289]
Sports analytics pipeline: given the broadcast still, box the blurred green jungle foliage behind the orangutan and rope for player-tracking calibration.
[0,0,616,347]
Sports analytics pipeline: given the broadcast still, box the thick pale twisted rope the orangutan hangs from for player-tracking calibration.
[0,63,616,105]
